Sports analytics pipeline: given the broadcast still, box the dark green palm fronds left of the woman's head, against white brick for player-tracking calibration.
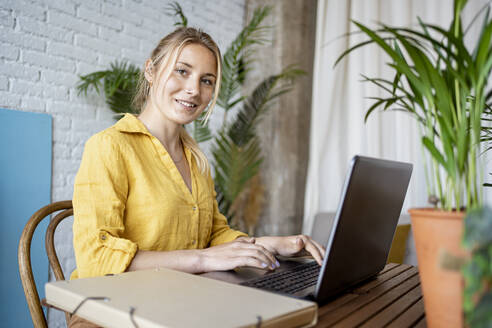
[77,62,140,113]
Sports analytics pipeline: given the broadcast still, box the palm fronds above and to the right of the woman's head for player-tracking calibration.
[169,2,304,229]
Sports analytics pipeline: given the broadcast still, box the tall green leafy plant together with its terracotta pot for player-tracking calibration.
[337,0,492,327]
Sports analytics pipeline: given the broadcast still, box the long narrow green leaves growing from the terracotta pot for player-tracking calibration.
[337,0,492,210]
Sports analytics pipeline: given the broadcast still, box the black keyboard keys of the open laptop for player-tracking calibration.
[241,262,320,294]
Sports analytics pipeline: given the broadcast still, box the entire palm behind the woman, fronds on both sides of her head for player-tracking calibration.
[77,2,304,233]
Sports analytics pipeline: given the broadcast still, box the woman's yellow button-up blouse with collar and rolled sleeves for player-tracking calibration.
[71,114,245,279]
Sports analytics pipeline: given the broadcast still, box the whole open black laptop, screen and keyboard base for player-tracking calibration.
[205,156,412,304]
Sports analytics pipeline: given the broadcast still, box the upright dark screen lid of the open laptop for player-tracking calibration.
[314,156,412,301]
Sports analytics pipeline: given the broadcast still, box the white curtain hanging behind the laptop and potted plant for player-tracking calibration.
[303,0,492,233]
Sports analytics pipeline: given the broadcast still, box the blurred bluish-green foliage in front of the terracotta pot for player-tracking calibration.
[462,207,492,327]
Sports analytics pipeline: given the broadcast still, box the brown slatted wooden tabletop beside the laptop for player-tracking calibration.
[316,263,426,328]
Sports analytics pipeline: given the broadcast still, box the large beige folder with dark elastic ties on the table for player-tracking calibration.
[45,269,318,328]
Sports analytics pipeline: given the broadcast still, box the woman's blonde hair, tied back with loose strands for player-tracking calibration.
[133,27,222,173]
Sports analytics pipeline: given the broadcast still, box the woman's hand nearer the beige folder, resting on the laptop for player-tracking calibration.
[200,237,279,272]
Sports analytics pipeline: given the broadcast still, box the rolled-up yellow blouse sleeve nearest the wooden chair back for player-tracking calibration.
[72,134,138,278]
